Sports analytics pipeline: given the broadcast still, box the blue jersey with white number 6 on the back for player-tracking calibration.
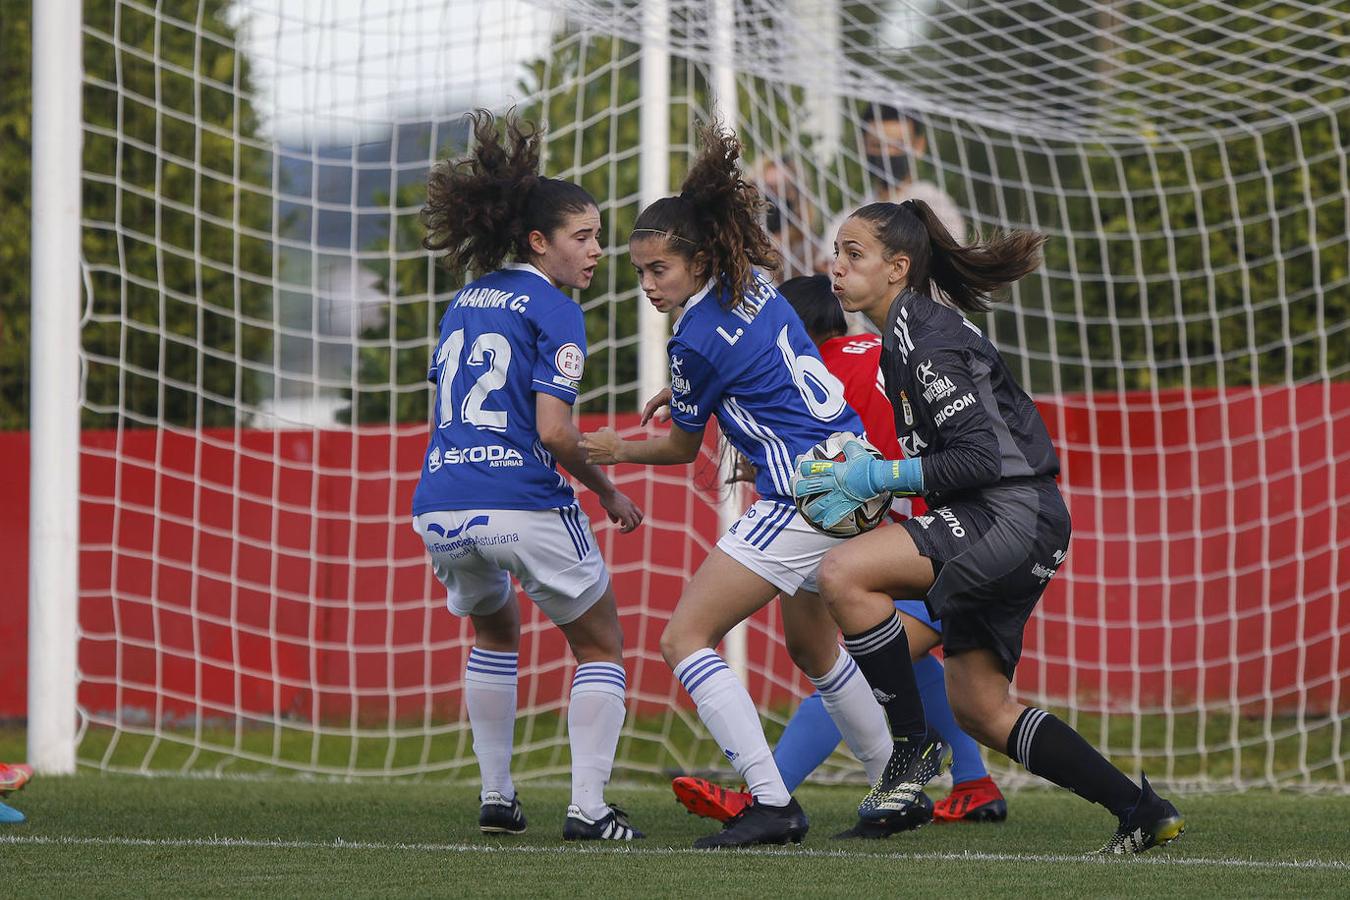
[667,273,863,503]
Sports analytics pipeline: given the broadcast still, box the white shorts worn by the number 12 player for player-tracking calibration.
[413,505,609,625]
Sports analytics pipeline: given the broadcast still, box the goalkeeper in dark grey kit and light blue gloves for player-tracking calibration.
[795,200,1184,853]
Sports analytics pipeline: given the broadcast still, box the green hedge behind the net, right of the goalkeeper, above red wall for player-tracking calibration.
[912,0,1350,391]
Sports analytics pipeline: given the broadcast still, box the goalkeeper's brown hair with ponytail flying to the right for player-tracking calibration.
[853,200,1045,313]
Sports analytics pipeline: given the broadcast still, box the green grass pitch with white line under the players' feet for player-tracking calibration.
[0,772,1350,899]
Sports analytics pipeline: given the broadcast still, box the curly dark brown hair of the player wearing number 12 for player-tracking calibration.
[421,109,598,274]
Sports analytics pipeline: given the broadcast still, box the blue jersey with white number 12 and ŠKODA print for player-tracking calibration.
[413,264,586,515]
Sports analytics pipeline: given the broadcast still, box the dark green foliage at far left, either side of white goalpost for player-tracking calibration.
[0,0,273,428]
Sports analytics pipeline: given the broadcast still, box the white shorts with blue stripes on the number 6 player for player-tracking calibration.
[717,501,844,596]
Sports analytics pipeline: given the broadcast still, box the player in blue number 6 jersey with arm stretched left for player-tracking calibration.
[583,127,890,847]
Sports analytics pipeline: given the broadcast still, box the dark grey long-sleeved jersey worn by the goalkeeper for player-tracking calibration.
[882,290,1060,506]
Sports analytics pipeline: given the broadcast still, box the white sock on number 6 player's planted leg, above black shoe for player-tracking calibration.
[675,649,788,807]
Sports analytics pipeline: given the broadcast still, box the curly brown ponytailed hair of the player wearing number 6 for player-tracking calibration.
[633,120,782,309]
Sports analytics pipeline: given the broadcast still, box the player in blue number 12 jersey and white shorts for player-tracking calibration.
[413,111,643,841]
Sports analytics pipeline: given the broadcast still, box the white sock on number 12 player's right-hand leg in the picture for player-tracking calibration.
[567,663,628,820]
